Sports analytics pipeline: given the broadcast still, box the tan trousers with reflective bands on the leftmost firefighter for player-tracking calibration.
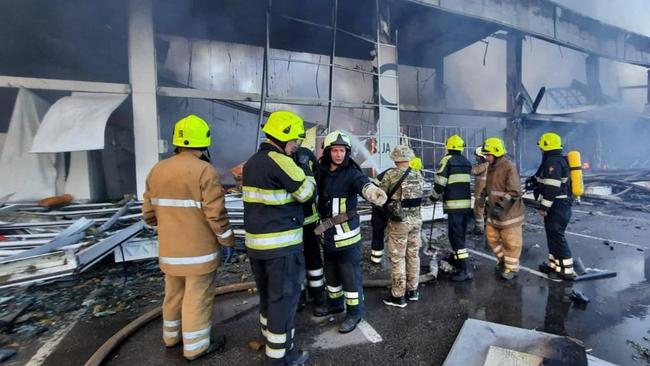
[163,272,215,358]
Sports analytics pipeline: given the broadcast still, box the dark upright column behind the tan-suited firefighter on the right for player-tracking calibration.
[504,32,523,163]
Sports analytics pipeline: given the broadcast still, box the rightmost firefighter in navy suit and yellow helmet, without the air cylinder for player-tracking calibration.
[535,132,576,280]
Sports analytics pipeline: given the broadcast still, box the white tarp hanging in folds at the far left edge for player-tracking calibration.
[0,89,57,201]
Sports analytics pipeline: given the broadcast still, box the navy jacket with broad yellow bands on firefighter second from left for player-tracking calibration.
[242,142,315,259]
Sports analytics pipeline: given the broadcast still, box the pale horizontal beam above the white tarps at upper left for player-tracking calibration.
[0,75,131,94]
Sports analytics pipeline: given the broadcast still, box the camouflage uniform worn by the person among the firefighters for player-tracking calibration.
[380,146,424,297]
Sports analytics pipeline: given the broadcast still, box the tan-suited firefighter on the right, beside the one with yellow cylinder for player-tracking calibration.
[483,137,526,281]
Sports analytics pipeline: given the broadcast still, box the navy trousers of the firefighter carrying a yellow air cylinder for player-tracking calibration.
[544,199,573,274]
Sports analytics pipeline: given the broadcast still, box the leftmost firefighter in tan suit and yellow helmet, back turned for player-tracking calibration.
[142,114,235,360]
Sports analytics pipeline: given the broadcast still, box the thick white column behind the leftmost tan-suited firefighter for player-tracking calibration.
[129,0,160,199]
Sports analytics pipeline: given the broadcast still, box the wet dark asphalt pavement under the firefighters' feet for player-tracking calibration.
[35,205,650,366]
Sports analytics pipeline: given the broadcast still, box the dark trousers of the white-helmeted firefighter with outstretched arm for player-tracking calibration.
[323,244,365,317]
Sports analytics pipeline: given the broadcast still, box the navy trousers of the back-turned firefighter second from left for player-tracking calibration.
[250,252,305,360]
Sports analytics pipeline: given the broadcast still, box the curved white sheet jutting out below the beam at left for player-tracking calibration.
[30,93,128,153]
